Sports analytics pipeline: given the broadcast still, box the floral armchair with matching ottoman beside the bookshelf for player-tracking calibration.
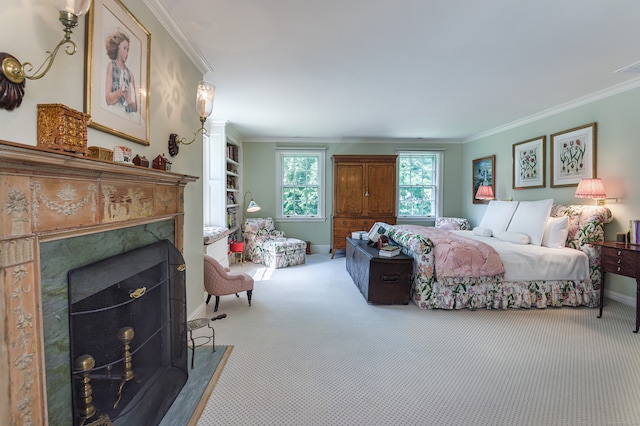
[243,217,307,268]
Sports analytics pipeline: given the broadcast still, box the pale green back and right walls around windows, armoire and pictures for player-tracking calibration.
[243,88,640,303]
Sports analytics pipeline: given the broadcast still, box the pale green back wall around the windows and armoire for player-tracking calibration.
[242,141,463,251]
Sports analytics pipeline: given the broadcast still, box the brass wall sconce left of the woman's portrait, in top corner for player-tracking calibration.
[0,0,91,111]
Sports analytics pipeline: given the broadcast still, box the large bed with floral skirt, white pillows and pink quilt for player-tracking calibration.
[372,200,612,309]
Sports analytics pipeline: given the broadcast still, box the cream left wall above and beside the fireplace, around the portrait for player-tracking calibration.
[0,0,204,313]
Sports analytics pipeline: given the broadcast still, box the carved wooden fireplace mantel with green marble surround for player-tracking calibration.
[0,141,198,425]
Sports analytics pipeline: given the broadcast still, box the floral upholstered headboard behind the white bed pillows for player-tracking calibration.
[551,204,613,289]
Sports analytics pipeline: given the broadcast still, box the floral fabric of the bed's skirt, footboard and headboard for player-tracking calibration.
[374,205,612,309]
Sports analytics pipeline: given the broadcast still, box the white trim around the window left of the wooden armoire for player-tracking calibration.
[275,148,327,222]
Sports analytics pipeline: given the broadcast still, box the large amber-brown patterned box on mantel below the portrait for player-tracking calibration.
[38,104,91,155]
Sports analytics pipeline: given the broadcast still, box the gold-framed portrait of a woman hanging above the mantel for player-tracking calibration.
[84,0,151,145]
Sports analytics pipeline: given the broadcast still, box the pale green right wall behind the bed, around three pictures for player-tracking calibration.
[461,85,640,302]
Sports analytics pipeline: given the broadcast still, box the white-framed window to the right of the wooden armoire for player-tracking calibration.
[398,151,442,218]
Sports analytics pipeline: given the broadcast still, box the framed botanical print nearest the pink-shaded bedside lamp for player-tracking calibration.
[551,123,596,188]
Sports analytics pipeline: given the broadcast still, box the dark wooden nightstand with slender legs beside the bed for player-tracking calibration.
[597,241,640,333]
